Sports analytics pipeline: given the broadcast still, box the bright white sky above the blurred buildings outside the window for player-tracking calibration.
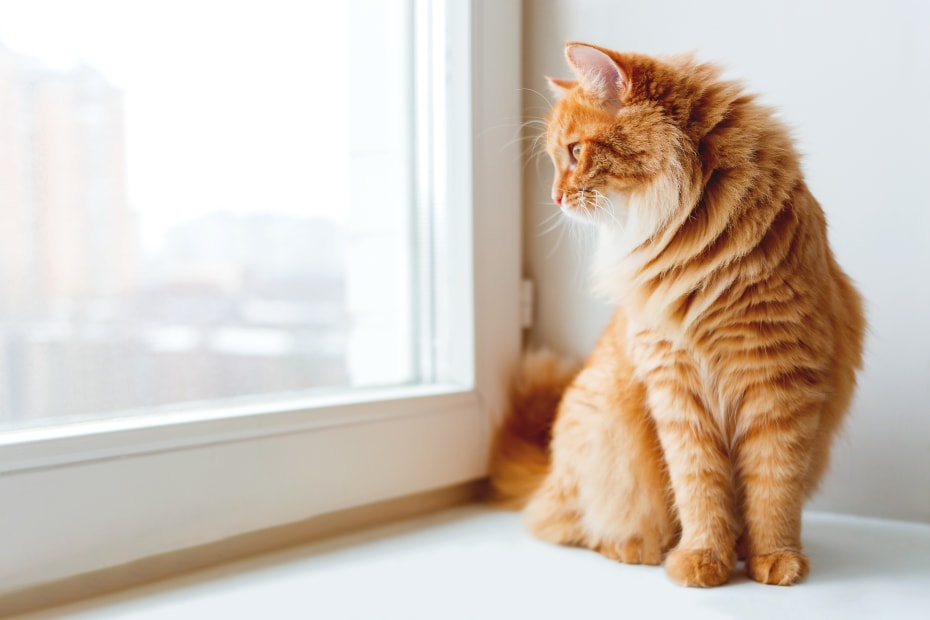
[0,0,349,246]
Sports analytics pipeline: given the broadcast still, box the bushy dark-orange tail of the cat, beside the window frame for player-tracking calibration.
[489,350,579,508]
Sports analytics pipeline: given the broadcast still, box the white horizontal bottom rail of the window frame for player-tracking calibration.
[0,388,492,597]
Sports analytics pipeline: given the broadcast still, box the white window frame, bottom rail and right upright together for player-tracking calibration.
[0,0,521,596]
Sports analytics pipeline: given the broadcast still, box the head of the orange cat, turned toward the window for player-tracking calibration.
[546,43,694,242]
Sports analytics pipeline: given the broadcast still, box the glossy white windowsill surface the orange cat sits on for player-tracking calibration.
[9,506,930,620]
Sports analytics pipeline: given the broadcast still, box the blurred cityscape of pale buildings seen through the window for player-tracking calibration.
[0,43,350,427]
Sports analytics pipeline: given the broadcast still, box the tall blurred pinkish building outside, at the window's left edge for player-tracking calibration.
[0,44,139,320]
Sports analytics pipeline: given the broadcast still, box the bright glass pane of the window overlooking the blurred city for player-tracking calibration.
[0,0,420,428]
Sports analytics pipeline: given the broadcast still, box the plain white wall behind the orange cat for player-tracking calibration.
[524,0,930,521]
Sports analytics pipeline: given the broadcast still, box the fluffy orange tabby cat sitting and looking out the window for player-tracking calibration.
[492,43,865,586]
